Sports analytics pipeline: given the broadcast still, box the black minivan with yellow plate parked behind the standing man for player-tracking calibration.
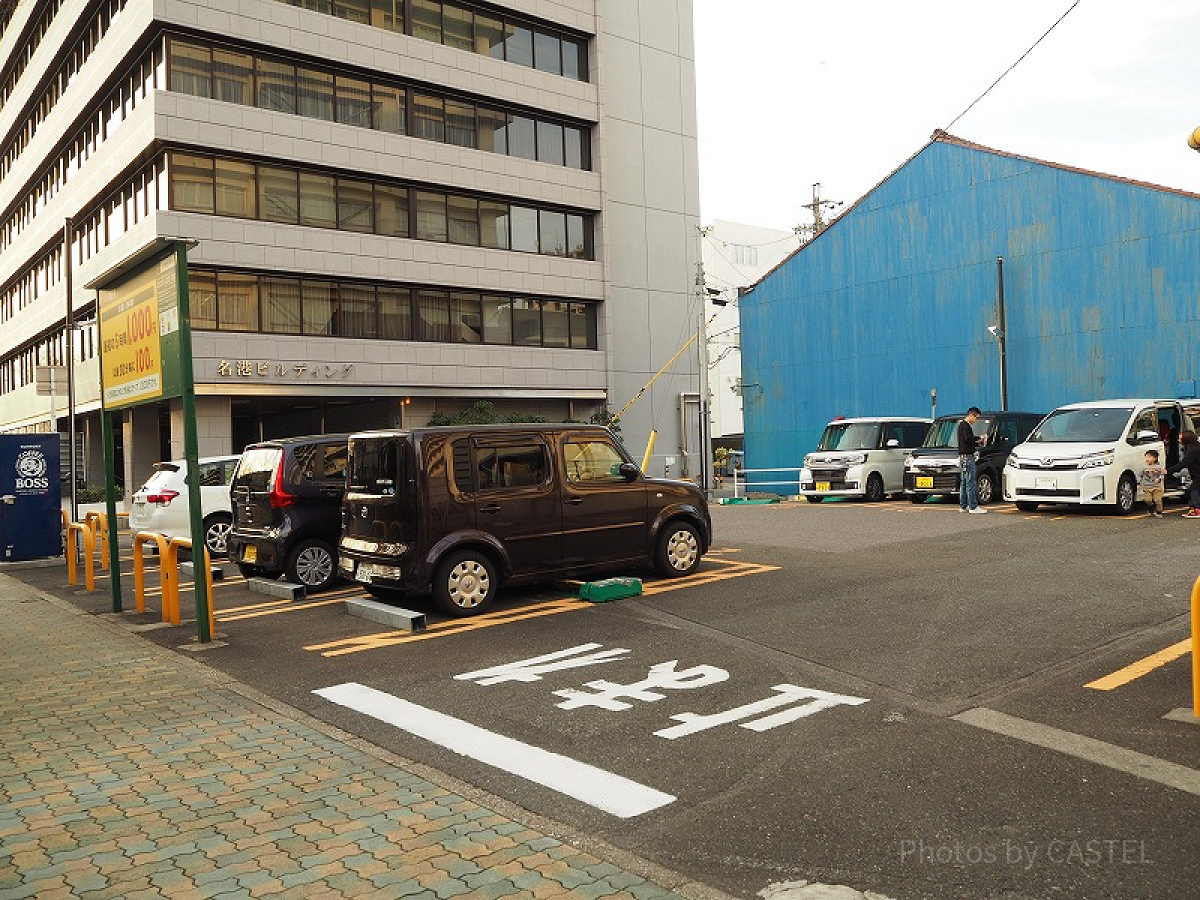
[904,412,1045,505]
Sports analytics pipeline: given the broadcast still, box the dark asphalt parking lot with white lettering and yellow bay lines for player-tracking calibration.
[21,500,1200,898]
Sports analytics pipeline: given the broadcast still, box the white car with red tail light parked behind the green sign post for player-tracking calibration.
[130,456,241,557]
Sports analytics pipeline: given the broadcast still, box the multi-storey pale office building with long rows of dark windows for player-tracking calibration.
[0,0,698,487]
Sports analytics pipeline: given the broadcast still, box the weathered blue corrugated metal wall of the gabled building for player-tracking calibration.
[740,140,1200,468]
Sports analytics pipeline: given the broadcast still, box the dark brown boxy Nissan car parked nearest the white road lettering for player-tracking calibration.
[338,425,712,616]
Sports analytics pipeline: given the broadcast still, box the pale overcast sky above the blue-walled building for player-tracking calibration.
[694,0,1200,229]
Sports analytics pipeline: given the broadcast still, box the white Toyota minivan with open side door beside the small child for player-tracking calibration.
[1004,400,1196,514]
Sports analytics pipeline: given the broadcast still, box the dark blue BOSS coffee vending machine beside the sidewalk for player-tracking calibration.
[0,434,62,562]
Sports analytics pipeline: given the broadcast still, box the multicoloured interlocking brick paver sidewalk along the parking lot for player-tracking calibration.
[0,575,716,900]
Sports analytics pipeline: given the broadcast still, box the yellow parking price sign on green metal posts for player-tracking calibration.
[91,240,212,642]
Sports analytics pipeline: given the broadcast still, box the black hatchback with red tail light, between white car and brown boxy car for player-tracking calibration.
[229,434,350,590]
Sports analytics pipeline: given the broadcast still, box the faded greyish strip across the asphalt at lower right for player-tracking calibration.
[953,707,1200,794]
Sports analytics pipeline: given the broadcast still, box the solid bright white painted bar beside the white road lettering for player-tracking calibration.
[313,682,676,818]
